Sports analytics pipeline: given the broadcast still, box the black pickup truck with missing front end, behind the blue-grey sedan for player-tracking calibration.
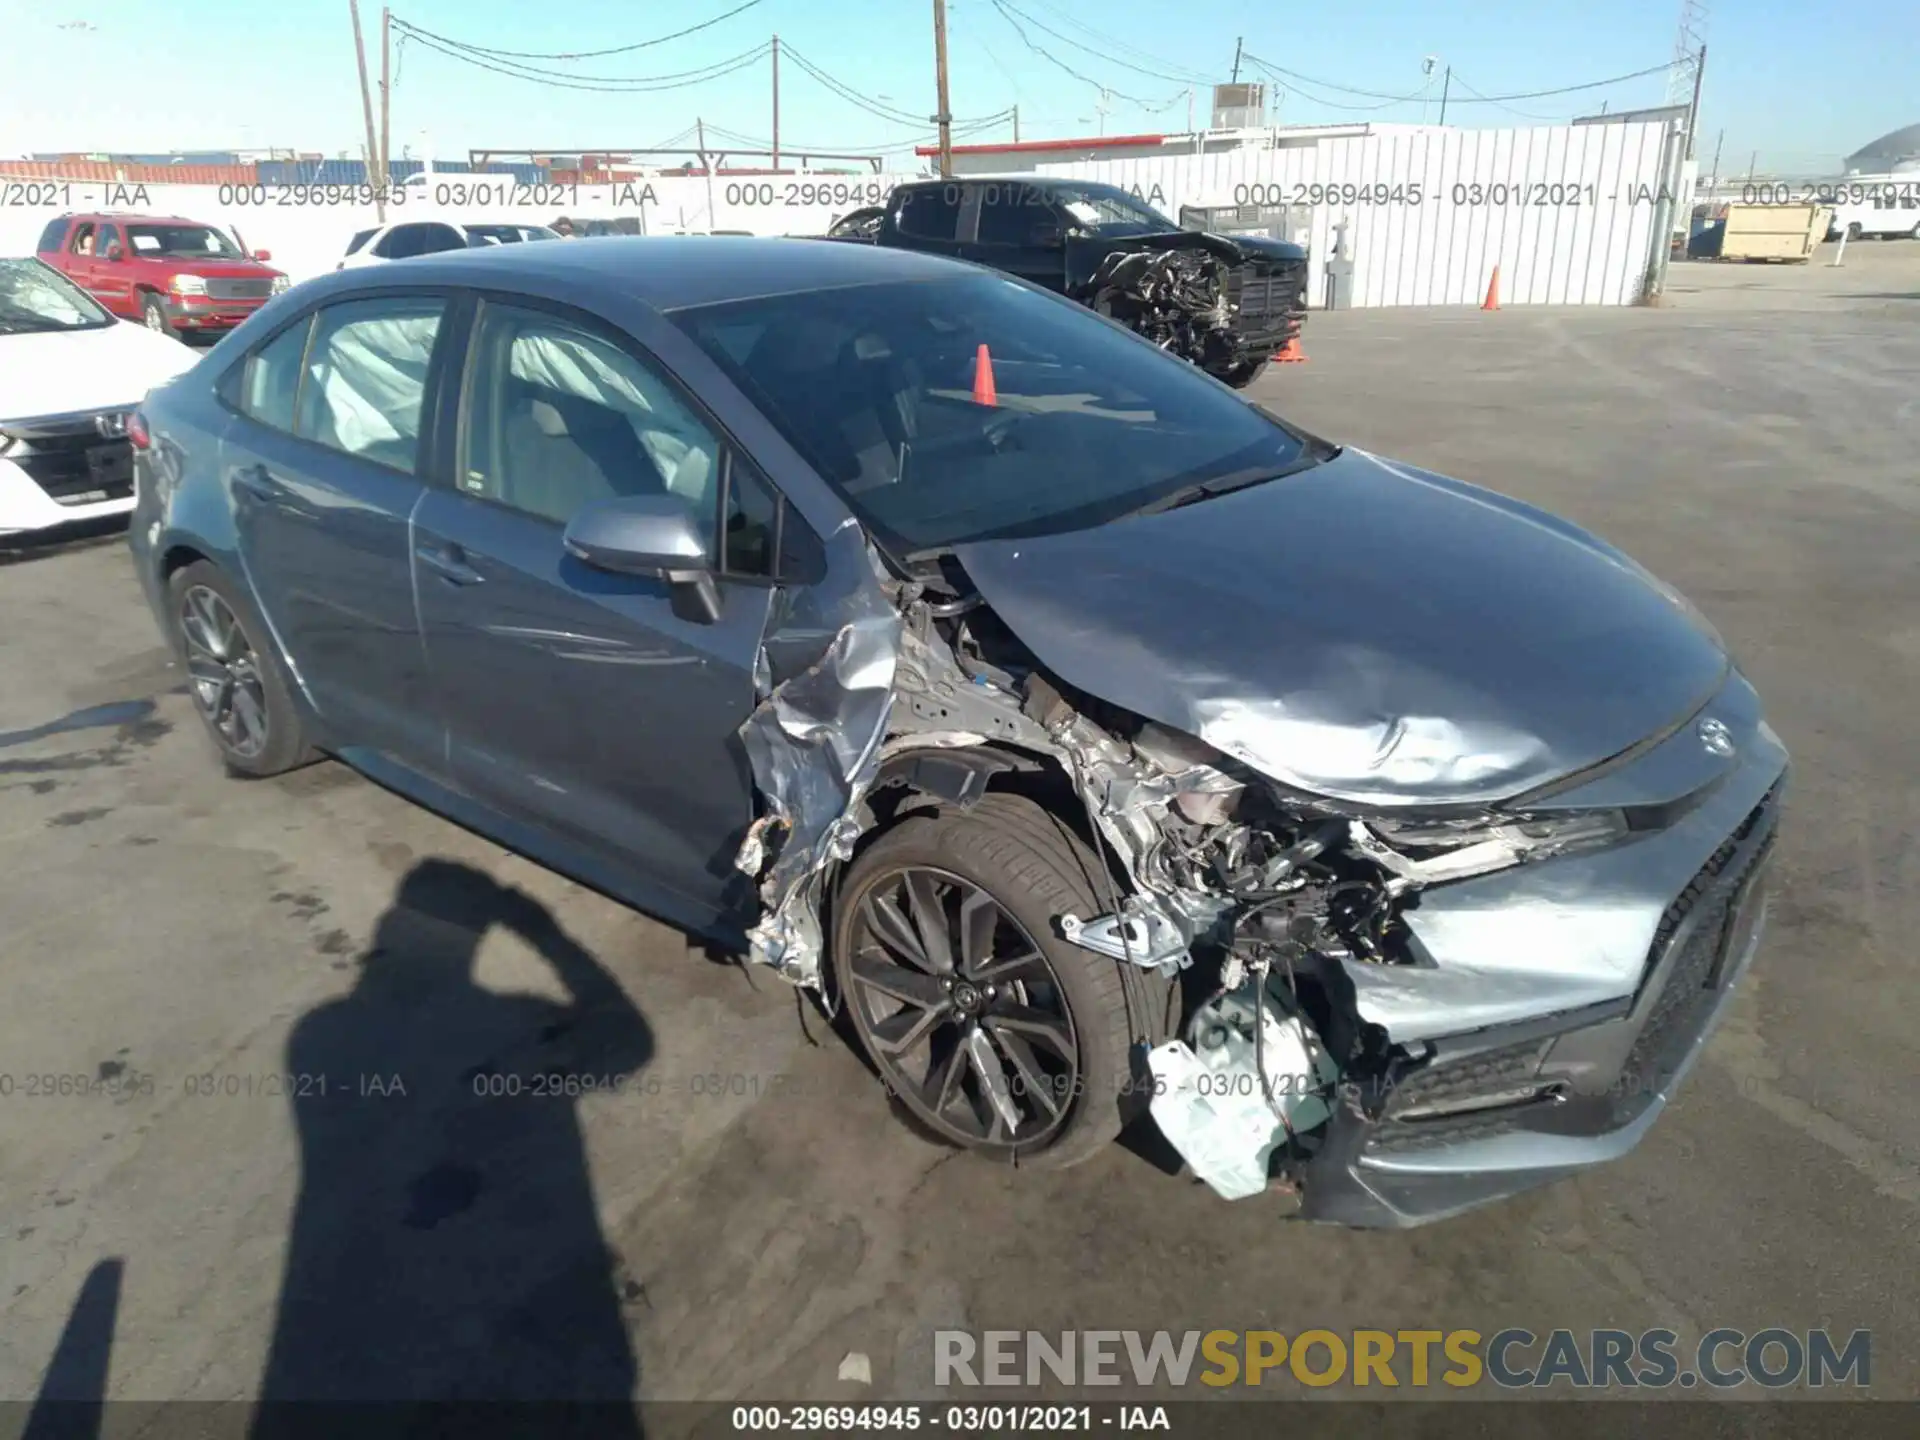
[826,177,1308,388]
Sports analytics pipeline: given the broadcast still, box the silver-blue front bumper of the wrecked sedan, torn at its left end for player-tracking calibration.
[1300,676,1788,1227]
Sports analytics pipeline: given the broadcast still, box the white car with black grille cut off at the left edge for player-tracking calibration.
[0,257,200,538]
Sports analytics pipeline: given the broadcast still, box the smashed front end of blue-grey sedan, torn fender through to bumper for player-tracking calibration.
[721,541,1786,1225]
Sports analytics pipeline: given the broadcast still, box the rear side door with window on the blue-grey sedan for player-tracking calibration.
[221,290,457,774]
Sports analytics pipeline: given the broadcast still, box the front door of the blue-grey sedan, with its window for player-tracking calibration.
[415,301,814,924]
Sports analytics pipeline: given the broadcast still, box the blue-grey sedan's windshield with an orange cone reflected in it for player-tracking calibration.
[672,275,1306,553]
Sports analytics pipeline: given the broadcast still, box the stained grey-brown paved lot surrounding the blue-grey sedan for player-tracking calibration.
[0,244,1920,1400]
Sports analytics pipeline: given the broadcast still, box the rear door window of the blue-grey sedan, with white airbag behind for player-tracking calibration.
[294,296,445,472]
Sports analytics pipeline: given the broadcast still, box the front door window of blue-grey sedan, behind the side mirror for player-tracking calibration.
[461,303,720,545]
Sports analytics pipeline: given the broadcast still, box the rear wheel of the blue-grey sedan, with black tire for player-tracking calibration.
[167,561,319,778]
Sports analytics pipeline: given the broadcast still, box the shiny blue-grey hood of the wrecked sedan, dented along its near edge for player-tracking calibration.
[956,449,1728,806]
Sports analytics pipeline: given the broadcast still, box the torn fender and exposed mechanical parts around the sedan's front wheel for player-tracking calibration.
[735,556,1658,1198]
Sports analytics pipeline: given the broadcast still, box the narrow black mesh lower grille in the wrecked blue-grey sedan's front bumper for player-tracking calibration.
[1615,787,1778,1123]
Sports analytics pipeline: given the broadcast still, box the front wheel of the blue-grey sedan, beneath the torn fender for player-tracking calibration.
[833,793,1167,1169]
